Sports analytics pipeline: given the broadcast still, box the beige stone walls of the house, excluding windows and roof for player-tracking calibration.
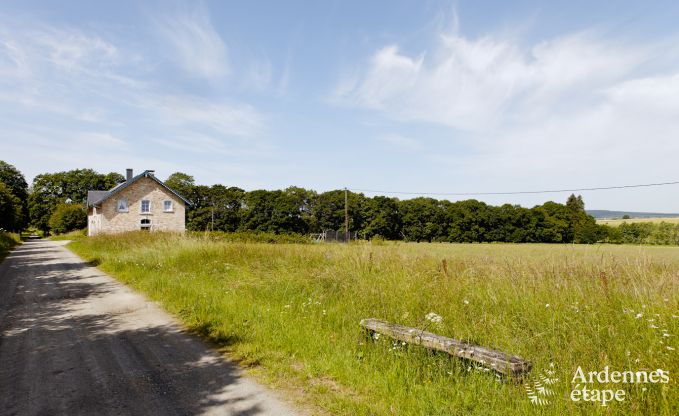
[89,177,185,235]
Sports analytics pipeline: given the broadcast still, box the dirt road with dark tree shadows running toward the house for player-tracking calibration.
[0,240,294,416]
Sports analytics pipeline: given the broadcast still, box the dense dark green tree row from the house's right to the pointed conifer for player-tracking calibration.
[165,172,605,243]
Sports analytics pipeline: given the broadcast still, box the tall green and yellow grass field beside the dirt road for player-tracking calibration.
[69,233,679,415]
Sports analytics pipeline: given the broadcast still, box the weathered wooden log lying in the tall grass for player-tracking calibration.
[361,318,533,377]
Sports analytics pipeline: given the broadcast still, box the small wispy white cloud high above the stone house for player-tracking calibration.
[155,6,229,79]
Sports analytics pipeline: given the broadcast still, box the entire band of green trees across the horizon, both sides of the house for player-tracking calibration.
[0,161,679,244]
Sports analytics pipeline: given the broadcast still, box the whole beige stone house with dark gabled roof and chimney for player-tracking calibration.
[87,169,191,236]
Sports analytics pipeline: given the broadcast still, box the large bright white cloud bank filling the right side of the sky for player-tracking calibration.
[334,22,679,210]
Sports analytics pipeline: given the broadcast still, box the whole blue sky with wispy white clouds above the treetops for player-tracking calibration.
[0,0,679,212]
